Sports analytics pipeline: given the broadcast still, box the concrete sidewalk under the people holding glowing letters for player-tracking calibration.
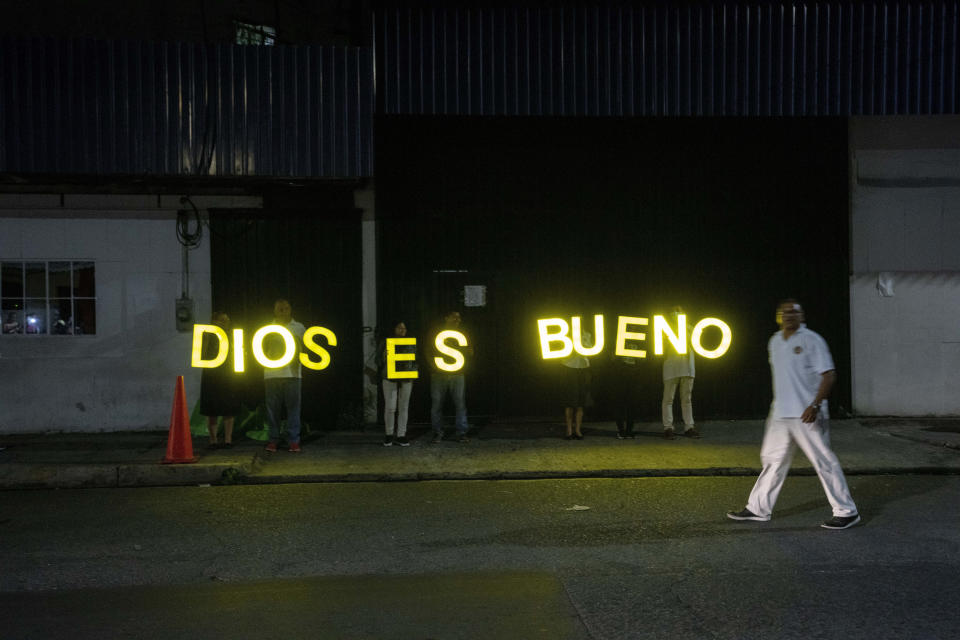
[0,419,960,489]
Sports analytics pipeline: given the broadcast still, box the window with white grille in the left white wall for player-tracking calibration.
[0,260,97,336]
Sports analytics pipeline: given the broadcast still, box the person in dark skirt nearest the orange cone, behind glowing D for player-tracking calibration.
[200,311,240,449]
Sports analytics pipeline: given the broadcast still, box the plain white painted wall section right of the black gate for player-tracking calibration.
[850,116,960,416]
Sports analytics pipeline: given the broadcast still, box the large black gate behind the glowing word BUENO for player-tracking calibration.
[376,116,850,420]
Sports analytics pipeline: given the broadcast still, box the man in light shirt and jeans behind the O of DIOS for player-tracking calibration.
[263,298,306,453]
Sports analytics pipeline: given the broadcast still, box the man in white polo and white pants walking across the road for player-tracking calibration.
[727,298,860,529]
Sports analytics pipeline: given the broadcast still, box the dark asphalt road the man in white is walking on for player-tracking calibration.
[0,476,960,638]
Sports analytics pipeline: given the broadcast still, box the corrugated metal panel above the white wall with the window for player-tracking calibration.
[0,38,374,177]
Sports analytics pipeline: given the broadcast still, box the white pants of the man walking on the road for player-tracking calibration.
[747,416,857,517]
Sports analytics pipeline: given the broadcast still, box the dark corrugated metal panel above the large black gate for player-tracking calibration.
[375,0,960,116]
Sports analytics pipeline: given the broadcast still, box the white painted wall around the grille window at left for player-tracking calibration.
[0,194,259,433]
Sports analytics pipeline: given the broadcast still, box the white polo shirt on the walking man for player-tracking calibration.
[767,324,836,418]
